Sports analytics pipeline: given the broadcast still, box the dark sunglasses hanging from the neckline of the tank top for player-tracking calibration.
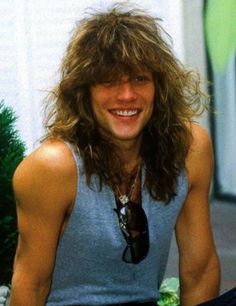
[116,201,149,264]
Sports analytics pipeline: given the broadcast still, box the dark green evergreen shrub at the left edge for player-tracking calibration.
[0,101,25,284]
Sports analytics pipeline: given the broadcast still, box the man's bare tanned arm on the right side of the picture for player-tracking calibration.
[176,126,220,306]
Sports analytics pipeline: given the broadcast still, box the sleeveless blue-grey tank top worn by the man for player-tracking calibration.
[46,146,188,306]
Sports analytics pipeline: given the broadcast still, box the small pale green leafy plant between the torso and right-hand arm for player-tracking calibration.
[157,277,180,306]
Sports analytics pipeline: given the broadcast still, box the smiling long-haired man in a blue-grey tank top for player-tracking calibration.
[10,7,219,306]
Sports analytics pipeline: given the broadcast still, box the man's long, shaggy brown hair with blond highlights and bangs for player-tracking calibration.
[45,6,207,202]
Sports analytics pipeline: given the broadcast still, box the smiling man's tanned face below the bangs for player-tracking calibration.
[90,71,155,144]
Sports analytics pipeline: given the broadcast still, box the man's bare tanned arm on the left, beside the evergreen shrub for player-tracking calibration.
[10,142,76,306]
